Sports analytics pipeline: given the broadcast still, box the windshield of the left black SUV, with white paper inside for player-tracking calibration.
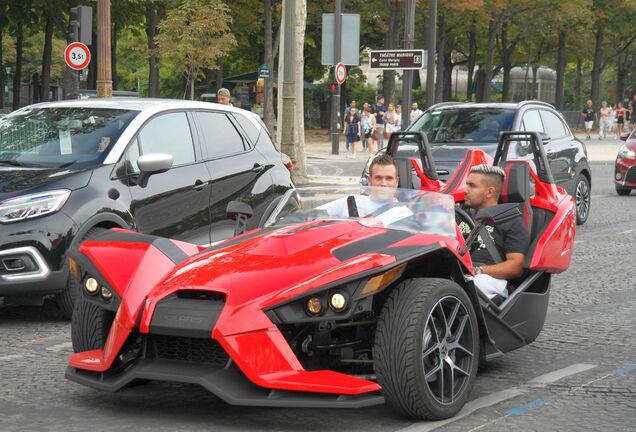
[0,107,138,168]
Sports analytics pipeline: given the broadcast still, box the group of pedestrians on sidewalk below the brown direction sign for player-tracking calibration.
[342,96,422,159]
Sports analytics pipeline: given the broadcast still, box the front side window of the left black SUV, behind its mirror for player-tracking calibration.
[137,112,196,166]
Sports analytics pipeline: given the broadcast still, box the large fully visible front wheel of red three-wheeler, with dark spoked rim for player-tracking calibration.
[374,278,479,420]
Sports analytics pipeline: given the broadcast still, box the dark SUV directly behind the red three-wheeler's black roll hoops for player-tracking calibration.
[362,101,592,225]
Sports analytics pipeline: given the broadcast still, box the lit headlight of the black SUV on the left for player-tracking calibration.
[0,189,71,223]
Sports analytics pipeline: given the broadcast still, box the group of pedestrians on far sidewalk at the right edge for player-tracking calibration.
[581,94,636,140]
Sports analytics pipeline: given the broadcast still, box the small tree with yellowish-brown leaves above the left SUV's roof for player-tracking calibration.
[156,0,236,99]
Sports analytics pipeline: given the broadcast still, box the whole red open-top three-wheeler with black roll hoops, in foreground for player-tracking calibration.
[66,132,576,419]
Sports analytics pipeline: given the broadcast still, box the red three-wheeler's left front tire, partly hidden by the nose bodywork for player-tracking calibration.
[71,296,115,352]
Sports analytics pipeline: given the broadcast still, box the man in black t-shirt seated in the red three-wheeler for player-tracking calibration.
[460,165,530,298]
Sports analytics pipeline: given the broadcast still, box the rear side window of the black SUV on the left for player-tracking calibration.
[197,111,246,159]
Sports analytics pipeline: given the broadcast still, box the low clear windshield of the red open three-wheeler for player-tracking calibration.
[265,186,456,238]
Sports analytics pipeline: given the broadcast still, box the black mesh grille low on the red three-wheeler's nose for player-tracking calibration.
[153,335,230,366]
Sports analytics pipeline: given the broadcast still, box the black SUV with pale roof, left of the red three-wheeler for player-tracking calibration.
[0,99,293,316]
